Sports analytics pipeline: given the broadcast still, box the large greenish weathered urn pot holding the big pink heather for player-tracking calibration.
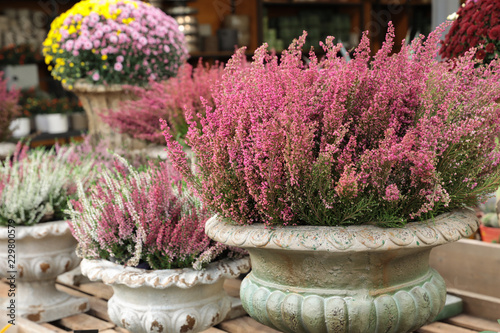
[205,210,478,333]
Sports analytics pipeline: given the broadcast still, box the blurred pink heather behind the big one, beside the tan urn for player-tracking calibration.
[100,60,223,144]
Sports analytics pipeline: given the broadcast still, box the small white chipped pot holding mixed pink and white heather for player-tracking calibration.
[81,257,250,333]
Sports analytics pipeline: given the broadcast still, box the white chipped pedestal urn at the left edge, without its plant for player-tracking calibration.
[0,221,89,322]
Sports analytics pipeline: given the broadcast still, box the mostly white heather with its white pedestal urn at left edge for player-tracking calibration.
[0,147,99,322]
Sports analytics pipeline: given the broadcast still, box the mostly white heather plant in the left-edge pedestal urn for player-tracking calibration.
[0,144,93,226]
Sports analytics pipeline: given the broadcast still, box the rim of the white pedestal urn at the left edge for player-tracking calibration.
[0,220,71,240]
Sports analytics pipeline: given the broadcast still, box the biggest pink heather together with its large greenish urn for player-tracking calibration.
[164,25,500,332]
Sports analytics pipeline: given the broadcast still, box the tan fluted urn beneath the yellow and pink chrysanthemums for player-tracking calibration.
[68,81,146,149]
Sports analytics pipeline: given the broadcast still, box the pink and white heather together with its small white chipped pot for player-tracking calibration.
[68,158,250,333]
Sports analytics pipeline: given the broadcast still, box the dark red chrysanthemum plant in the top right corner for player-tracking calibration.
[440,0,500,64]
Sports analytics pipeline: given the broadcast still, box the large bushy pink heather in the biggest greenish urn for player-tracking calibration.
[164,25,500,226]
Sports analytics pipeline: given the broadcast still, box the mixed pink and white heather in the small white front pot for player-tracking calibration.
[67,158,246,269]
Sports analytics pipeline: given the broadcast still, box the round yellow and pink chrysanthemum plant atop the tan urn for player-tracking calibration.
[43,0,188,89]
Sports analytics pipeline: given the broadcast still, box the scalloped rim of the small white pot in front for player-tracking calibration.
[81,256,254,289]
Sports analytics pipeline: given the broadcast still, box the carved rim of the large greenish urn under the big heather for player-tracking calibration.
[205,209,479,252]
